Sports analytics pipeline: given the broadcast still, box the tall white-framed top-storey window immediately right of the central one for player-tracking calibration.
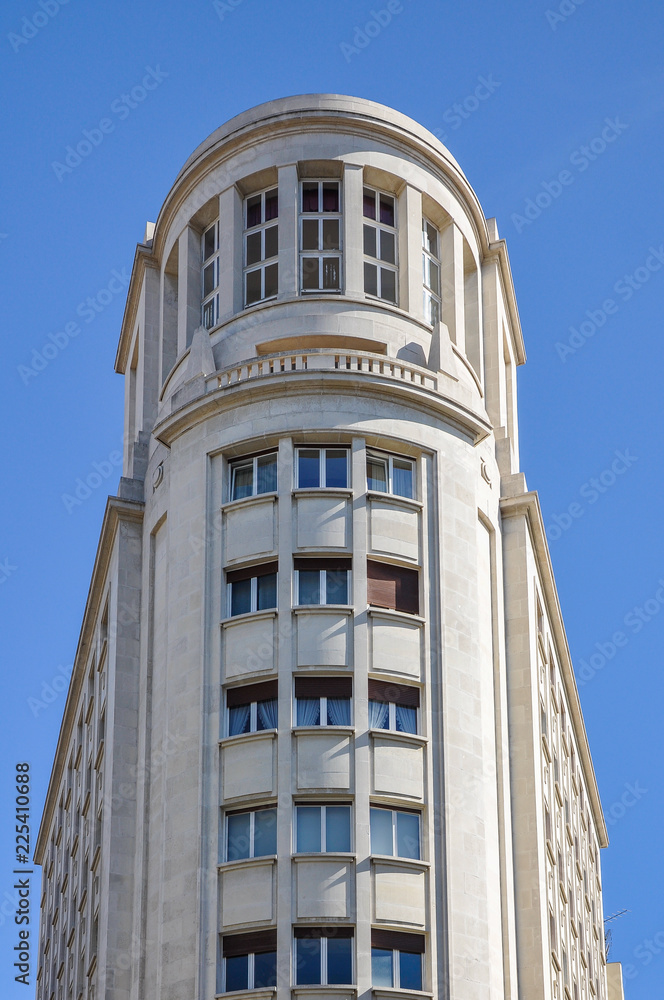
[363,188,397,302]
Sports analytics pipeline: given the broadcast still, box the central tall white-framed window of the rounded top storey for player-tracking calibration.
[300,181,341,292]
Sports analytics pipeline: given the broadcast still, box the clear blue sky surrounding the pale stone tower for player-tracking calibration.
[0,0,664,1000]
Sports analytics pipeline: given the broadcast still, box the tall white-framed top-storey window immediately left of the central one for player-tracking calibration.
[244,188,279,306]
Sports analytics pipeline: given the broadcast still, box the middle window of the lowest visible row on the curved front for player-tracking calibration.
[294,927,353,986]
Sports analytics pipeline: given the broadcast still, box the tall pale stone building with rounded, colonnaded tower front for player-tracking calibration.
[36,95,622,1000]
